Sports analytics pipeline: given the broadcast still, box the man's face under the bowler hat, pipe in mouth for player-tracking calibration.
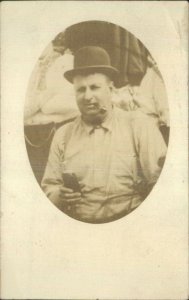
[73,73,113,119]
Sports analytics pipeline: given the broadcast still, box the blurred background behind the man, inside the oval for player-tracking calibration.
[24,21,169,183]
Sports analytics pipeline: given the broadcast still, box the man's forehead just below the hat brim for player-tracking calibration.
[73,73,109,86]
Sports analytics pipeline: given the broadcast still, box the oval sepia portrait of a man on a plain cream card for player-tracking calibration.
[24,20,170,223]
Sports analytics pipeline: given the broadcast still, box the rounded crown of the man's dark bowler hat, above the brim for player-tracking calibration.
[74,46,111,68]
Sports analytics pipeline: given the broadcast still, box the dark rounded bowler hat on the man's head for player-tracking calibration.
[64,46,119,83]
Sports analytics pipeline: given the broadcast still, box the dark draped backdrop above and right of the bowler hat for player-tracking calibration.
[53,21,149,87]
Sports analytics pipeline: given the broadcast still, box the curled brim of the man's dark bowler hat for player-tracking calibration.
[64,65,119,83]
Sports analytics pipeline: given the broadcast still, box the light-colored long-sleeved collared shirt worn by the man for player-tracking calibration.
[42,108,166,223]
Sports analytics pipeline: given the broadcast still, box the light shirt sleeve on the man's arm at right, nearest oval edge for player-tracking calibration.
[134,113,167,185]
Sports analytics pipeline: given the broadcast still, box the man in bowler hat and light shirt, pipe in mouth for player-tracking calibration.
[42,46,166,223]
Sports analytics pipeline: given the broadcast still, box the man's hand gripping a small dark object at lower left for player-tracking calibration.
[50,186,81,211]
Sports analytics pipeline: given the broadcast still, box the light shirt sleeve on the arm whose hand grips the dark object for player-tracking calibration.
[41,128,65,199]
